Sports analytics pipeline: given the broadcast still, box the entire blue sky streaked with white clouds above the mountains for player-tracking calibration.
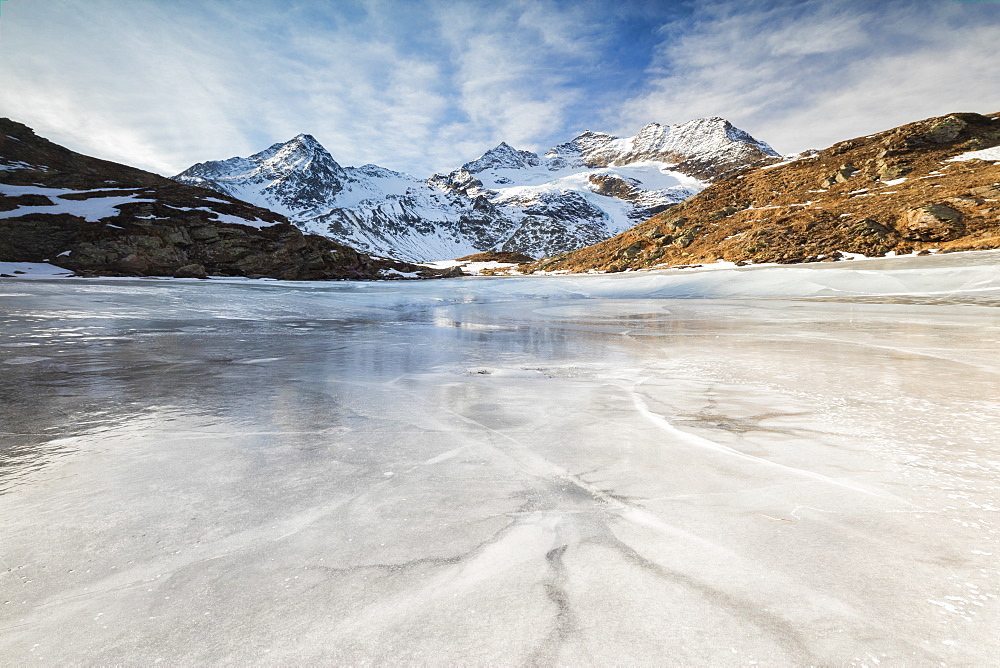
[0,0,1000,176]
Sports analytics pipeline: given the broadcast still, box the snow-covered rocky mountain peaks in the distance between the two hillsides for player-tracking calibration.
[173,117,777,261]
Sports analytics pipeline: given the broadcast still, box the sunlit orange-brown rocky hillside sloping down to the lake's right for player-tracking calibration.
[521,113,1000,273]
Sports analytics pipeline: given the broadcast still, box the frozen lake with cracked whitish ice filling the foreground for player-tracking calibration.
[0,254,1000,666]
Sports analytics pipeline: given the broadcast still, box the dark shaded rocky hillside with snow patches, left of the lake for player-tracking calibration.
[0,118,454,280]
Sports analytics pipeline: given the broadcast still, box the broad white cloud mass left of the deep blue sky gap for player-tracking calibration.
[0,0,612,175]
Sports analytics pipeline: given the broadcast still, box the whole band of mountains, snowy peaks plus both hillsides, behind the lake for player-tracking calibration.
[0,113,1000,280]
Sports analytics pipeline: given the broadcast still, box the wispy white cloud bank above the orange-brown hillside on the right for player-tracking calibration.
[625,0,1000,152]
